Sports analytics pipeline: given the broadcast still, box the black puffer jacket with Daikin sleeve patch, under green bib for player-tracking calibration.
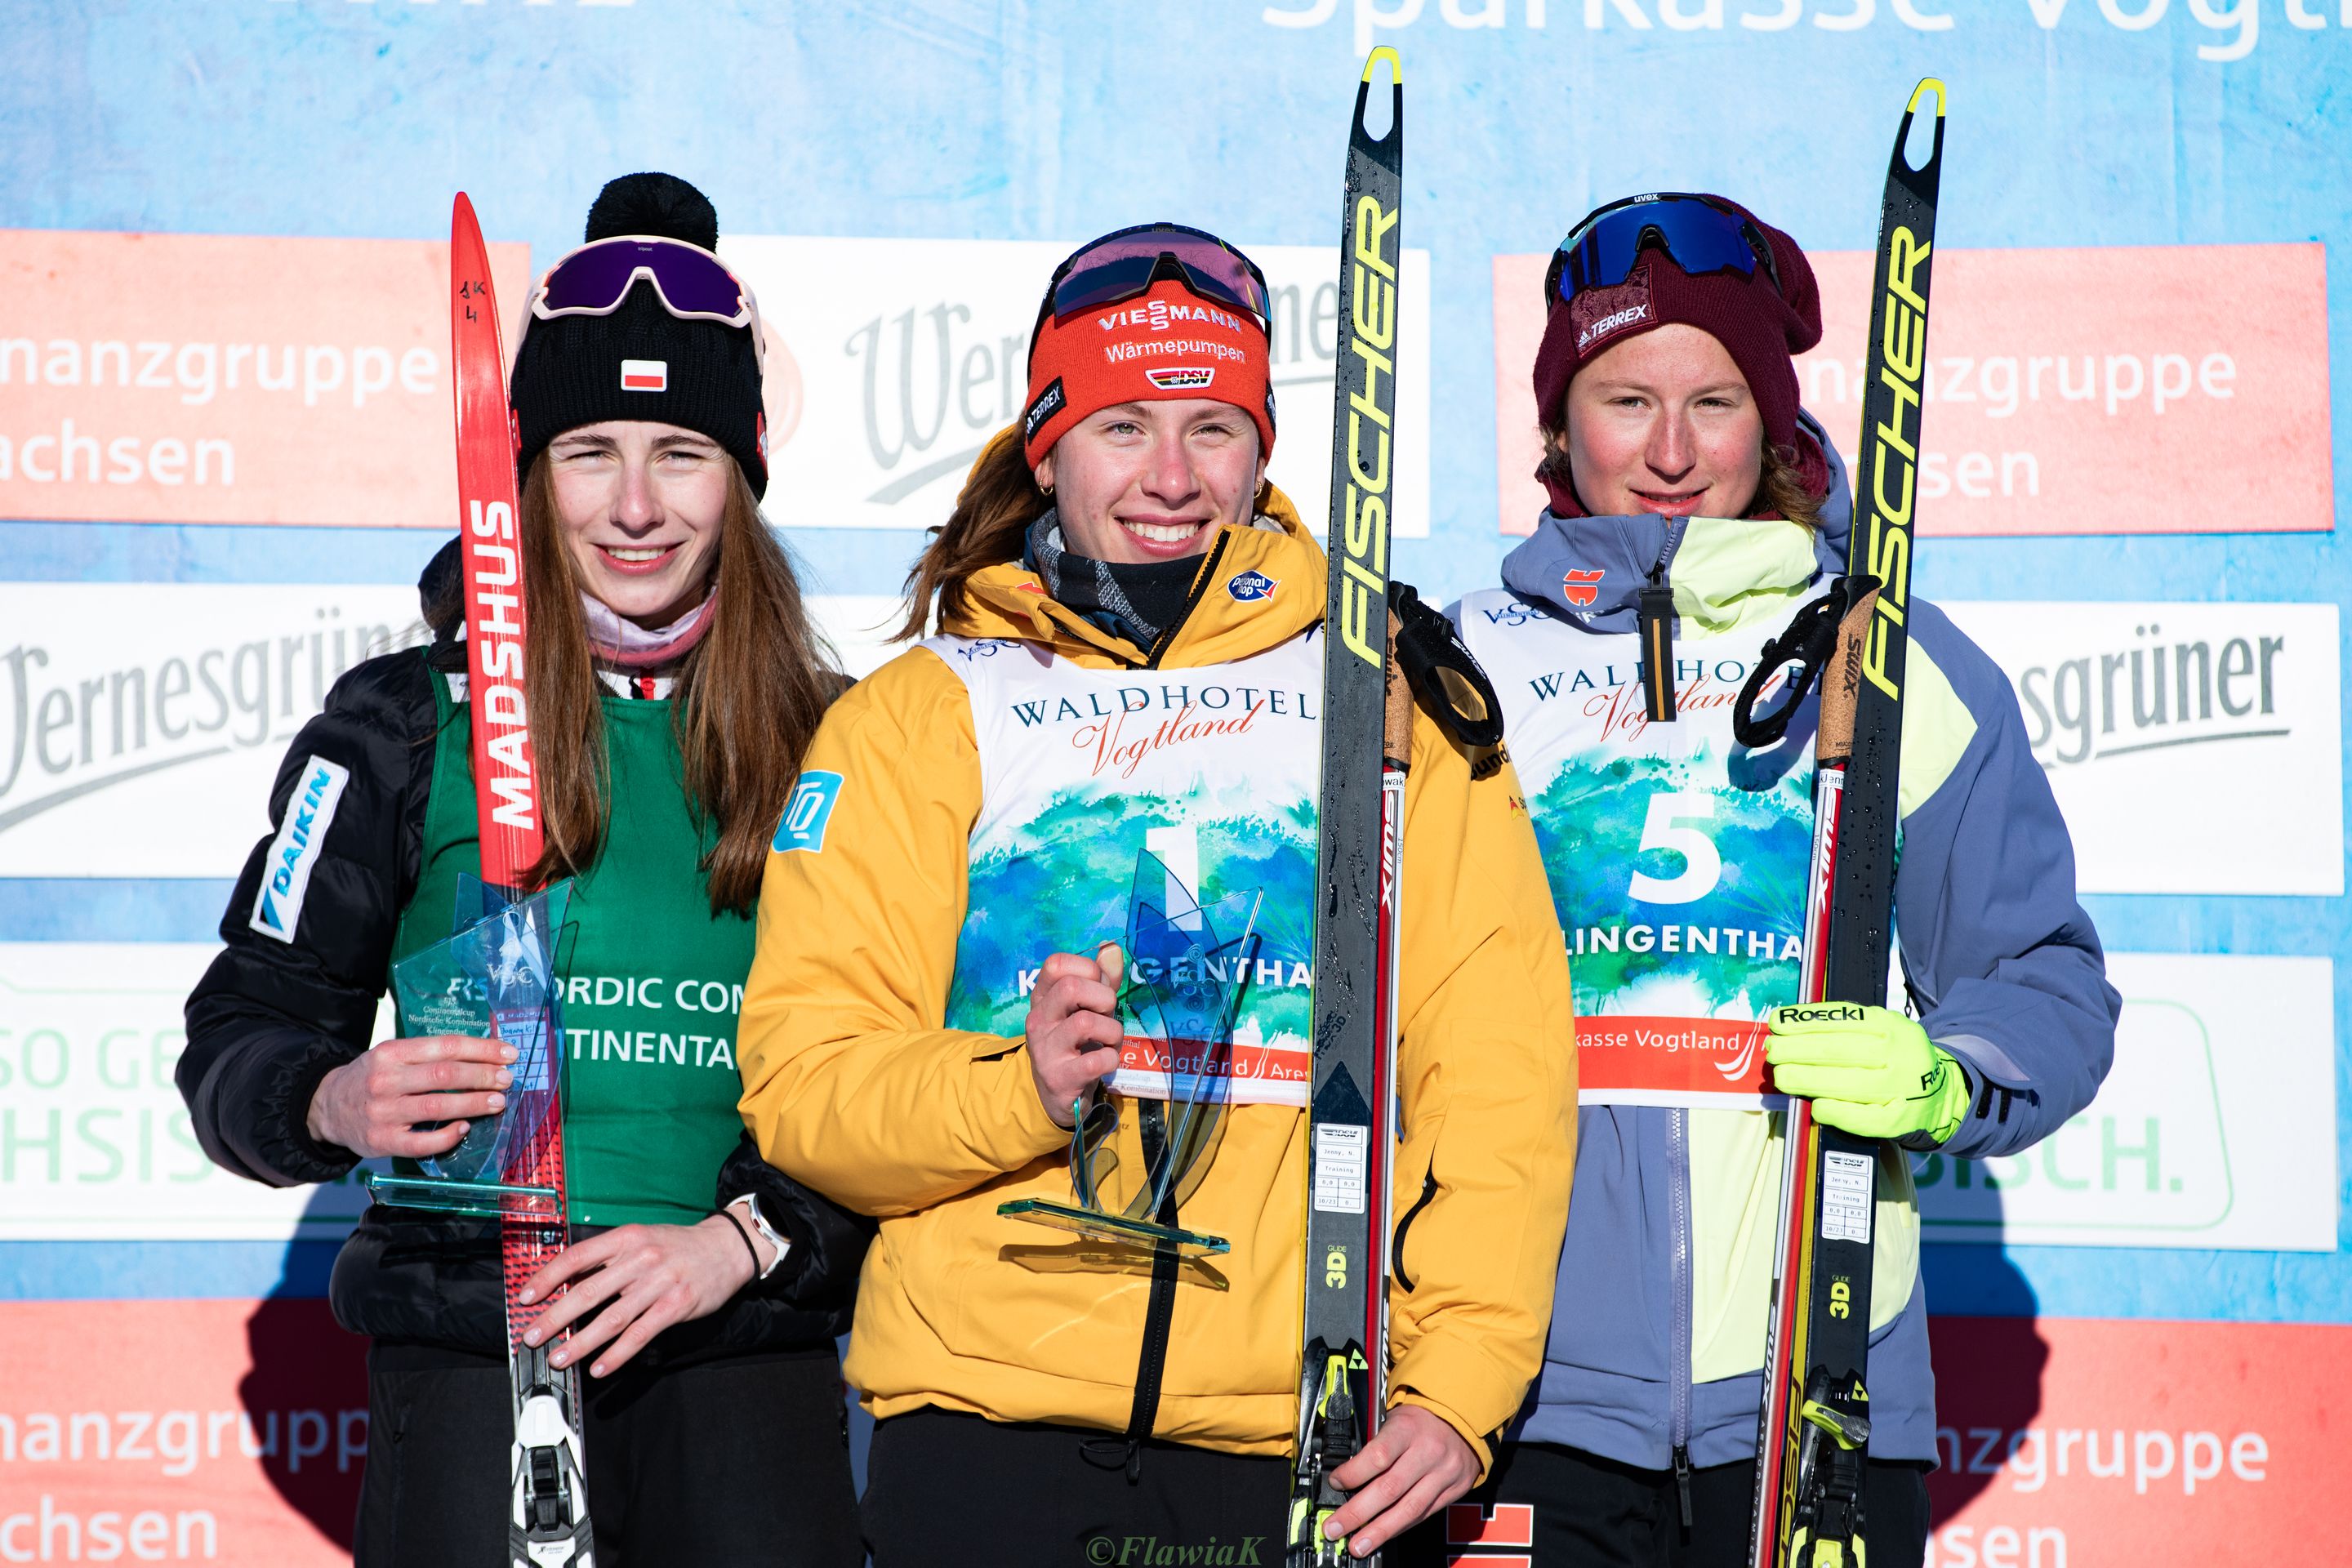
[179,550,872,1365]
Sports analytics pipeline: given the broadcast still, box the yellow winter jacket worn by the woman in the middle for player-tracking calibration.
[738,496,1576,1467]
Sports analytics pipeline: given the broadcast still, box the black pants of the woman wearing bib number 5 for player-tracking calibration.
[1385,1443,1929,1568]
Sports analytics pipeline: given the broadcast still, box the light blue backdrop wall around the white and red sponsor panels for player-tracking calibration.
[0,0,2352,1354]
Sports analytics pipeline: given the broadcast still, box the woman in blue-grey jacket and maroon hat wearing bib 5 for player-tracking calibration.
[1423,193,2119,1568]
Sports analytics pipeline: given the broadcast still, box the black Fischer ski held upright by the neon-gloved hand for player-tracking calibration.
[1750,78,1945,1568]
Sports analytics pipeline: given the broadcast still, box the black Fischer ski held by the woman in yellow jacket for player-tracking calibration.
[1284,49,1411,1568]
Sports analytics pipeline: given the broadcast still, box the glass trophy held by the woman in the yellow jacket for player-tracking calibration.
[997,849,1263,1258]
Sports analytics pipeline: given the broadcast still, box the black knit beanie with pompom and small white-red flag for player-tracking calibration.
[508,174,767,496]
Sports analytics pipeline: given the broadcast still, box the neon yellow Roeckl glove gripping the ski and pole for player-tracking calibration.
[1764,1001,1969,1145]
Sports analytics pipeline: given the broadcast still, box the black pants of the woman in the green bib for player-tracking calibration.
[355,1345,858,1568]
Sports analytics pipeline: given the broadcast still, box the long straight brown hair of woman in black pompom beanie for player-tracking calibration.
[522,454,847,915]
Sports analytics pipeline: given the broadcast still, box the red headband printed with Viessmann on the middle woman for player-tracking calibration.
[1021,278,1275,468]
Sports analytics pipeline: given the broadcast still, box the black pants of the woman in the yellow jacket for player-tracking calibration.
[865,1410,1291,1568]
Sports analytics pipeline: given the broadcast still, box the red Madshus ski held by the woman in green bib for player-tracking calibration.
[449,193,595,1568]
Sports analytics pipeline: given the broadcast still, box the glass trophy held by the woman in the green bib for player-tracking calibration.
[360,877,572,1220]
